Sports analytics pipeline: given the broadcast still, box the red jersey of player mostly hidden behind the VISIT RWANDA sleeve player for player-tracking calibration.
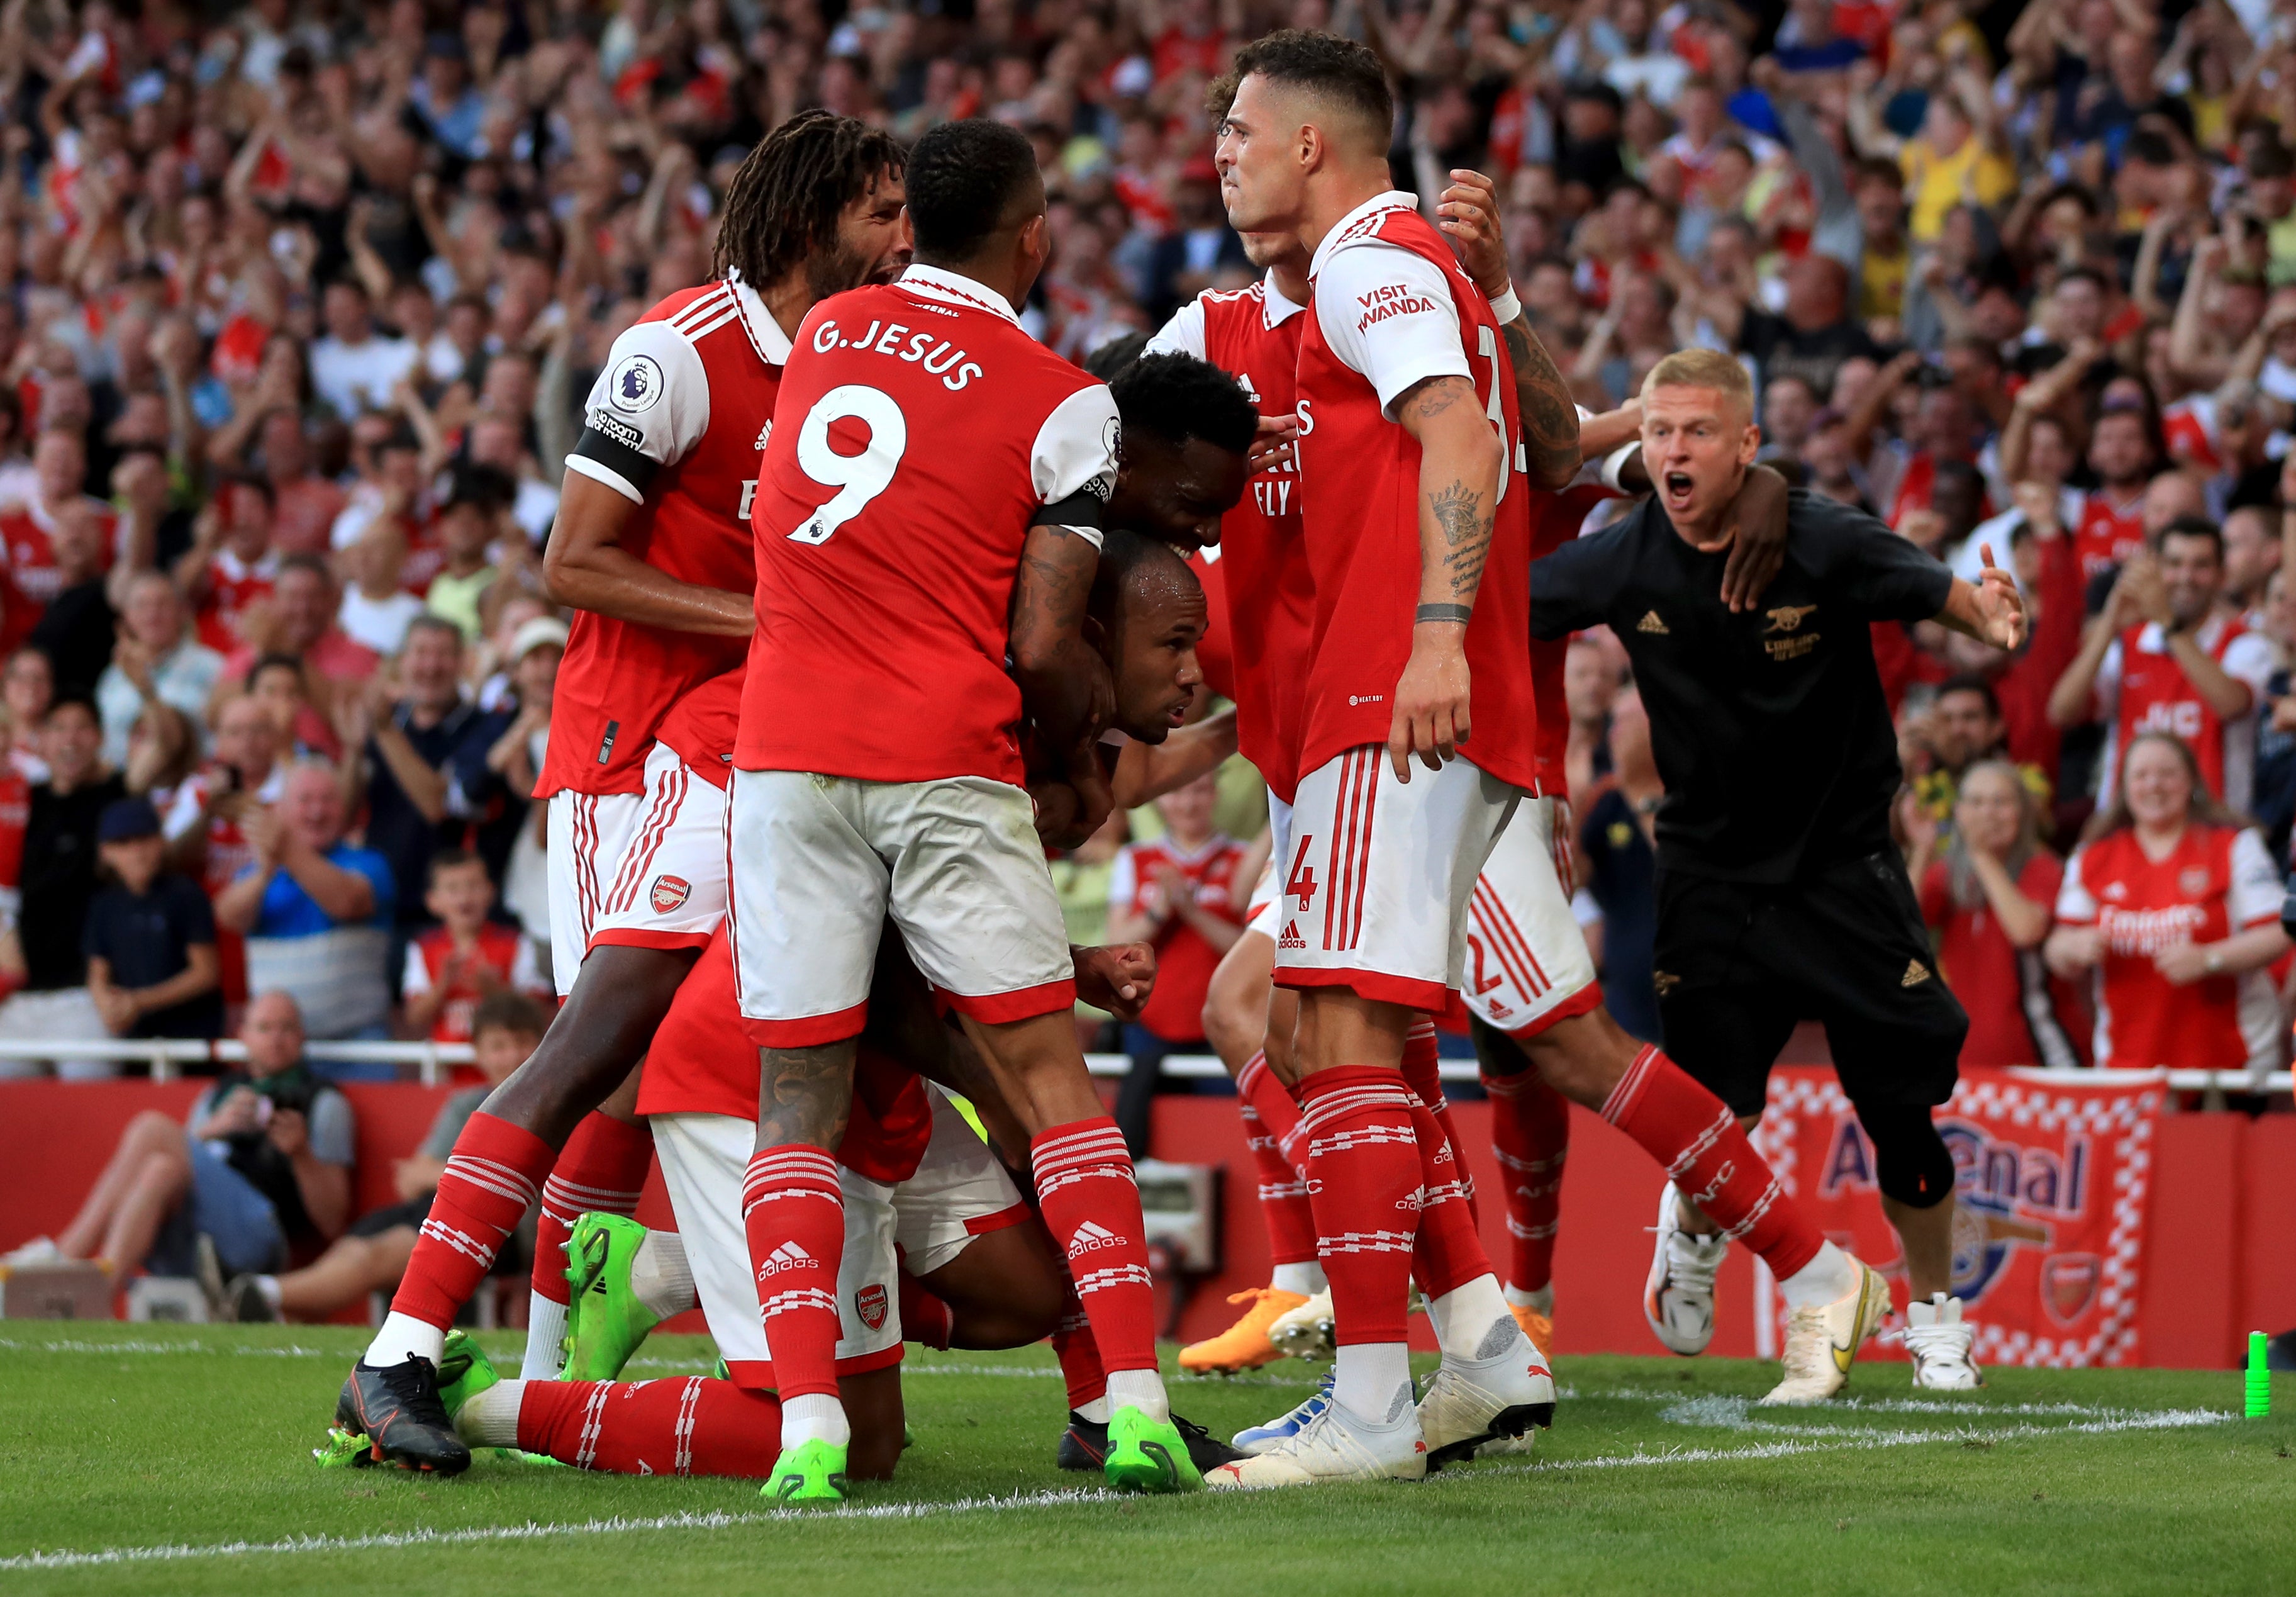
[1148,278,1315,804]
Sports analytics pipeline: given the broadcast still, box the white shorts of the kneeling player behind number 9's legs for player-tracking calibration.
[650,1082,1028,1388]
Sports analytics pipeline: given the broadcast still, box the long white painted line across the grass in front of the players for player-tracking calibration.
[0,1409,2232,1574]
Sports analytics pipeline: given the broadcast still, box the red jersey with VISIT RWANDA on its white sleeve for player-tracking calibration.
[1297,193,1539,793]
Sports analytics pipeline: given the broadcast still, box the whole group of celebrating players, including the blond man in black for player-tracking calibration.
[309,21,2023,1501]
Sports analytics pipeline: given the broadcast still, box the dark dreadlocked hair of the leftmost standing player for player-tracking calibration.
[710,110,902,289]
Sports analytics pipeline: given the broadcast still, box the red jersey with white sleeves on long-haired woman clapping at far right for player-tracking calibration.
[2057,825,2280,1071]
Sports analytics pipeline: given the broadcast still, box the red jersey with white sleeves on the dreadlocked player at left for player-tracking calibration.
[535,283,790,797]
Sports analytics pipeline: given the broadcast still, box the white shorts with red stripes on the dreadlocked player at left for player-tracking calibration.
[590,742,725,949]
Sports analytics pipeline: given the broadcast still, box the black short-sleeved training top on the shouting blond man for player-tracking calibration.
[1532,490,1954,882]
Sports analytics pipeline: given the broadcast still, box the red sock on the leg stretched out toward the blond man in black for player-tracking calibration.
[1603,1048,1825,1280]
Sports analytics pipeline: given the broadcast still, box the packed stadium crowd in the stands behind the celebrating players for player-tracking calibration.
[0,0,2296,1098]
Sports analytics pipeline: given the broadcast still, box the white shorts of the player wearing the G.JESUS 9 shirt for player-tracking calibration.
[730,770,1077,1048]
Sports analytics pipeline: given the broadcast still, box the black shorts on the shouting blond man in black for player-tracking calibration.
[1651,850,1970,1114]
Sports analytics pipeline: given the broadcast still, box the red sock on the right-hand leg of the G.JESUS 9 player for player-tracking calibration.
[1028,1114,1155,1369]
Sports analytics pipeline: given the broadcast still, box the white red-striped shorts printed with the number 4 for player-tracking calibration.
[1276,742,1525,1013]
